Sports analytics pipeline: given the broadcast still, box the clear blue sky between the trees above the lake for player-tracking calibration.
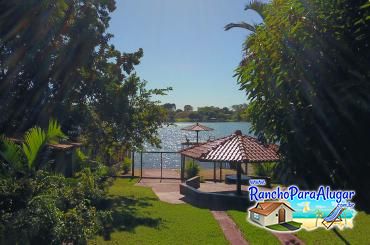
[108,0,260,109]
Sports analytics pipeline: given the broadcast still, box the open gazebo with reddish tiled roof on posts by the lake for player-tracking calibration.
[180,130,279,195]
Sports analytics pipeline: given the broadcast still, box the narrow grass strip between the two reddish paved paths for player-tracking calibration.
[227,211,280,245]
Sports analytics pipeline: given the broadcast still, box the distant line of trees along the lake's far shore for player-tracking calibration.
[162,103,248,122]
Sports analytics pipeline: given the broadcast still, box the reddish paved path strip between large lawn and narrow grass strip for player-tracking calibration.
[211,211,248,245]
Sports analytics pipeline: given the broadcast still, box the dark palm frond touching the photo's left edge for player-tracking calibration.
[0,136,22,168]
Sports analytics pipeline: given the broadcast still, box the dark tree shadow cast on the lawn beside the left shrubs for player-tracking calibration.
[102,196,162,240]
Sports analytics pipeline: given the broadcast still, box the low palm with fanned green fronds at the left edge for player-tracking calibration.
[0,120,66,170]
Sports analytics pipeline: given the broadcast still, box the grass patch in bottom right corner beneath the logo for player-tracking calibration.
[295,212,370,245]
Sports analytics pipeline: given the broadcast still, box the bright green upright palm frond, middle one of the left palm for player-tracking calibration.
[22,127,47,168]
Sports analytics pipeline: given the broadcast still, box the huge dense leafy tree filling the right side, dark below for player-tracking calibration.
[236,0,370,209]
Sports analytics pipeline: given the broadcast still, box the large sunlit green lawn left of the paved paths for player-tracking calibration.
[89,178,228,244]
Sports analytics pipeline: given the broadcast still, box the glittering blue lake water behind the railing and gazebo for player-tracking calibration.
[135,122,250,168]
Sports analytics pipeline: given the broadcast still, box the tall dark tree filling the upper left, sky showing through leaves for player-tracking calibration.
[0,0,169,153]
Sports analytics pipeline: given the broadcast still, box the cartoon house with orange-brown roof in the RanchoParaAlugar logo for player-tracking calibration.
[249,202,294,226]
